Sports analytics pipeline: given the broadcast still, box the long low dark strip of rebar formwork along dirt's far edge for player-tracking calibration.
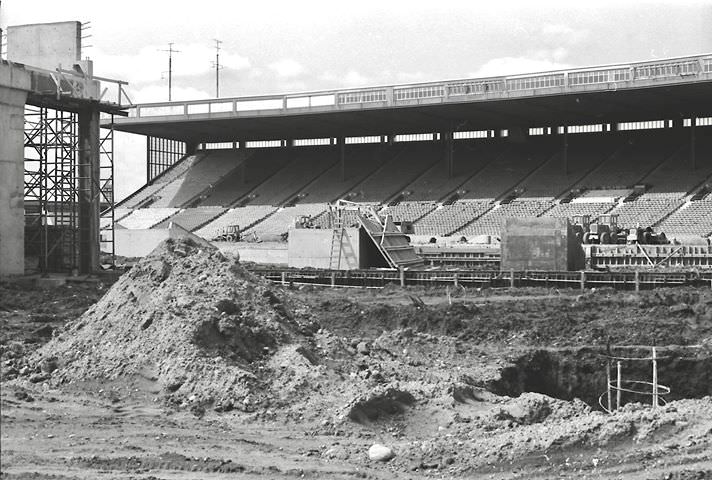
[247,265,712,290]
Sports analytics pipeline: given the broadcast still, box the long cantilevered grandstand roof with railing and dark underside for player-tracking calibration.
[107,55,712,142]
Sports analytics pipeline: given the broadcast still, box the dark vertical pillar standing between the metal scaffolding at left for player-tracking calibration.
[77,109,101,273]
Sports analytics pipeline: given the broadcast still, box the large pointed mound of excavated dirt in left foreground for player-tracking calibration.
[34,239,311,410]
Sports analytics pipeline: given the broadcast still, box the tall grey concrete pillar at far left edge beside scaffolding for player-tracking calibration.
[0,62,30,275]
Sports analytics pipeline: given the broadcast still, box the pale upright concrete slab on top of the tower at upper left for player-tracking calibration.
[7,22,82,70]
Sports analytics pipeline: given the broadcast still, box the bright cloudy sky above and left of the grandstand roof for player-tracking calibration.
[0,0,712,198]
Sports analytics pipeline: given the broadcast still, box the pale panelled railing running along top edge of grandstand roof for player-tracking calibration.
[130,54,712,118]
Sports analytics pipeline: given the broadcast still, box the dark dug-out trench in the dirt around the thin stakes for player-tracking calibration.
[487,346,712,409]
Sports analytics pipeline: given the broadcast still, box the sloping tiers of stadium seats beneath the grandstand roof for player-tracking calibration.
[114,129,712,239]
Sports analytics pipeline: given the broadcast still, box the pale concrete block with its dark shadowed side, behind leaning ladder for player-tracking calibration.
[288,228,388,270]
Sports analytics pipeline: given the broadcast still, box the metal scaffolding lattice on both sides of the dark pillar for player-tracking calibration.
[24,105,114,274]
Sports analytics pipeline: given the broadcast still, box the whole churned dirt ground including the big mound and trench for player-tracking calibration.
[0,242,712,479]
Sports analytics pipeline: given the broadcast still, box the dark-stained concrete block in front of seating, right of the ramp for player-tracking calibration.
[501,217,584,271]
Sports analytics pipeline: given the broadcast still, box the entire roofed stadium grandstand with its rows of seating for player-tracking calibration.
[107,55,712,246]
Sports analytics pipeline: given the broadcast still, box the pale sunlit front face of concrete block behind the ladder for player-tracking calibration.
[288,228,362,270]
